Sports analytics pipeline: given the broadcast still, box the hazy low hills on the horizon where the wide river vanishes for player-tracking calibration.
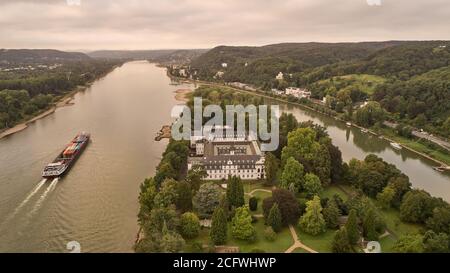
[88,49,207,62]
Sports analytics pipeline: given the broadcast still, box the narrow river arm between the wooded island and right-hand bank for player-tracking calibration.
[267,99,450,202]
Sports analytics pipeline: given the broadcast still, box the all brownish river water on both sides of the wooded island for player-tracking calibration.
[0,62,450,252]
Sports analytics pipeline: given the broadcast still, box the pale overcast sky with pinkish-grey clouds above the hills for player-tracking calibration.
[0,0,450,50]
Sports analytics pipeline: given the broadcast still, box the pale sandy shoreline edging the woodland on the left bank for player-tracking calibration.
[0,86,83,139]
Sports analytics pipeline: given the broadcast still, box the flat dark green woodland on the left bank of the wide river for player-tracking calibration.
[0,57,120,130]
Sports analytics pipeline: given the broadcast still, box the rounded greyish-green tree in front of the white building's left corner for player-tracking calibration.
[192,183,222,218]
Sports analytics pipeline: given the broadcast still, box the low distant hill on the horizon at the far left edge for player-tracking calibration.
[0,49,90,63]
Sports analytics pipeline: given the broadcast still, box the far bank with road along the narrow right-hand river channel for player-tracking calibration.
[169,75,450,168]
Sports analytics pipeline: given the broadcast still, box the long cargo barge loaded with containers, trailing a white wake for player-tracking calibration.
[42,132,91,178]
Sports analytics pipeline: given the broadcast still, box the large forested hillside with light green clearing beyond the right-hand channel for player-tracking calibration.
[191,41,450,137]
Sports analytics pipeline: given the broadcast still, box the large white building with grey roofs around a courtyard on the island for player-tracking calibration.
[188,127,265,180]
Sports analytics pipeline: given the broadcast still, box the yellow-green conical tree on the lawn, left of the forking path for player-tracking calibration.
[231,206,256,241]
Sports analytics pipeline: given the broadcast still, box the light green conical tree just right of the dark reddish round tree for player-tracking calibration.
[299,196,326,236]
